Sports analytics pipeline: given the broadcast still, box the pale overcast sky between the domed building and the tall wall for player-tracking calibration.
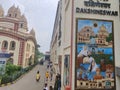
[0,0,59,53]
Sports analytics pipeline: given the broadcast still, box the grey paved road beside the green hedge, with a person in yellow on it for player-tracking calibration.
[0,65,46,90]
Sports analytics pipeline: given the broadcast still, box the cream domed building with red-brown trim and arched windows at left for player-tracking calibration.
[0,5,37,67]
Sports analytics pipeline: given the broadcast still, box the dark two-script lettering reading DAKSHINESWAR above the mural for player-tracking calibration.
[76,0,118,16]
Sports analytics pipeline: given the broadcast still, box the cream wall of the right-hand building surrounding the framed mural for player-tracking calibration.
[51,0,120,90]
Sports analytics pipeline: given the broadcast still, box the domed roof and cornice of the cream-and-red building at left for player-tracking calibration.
[0,5,37,44]
